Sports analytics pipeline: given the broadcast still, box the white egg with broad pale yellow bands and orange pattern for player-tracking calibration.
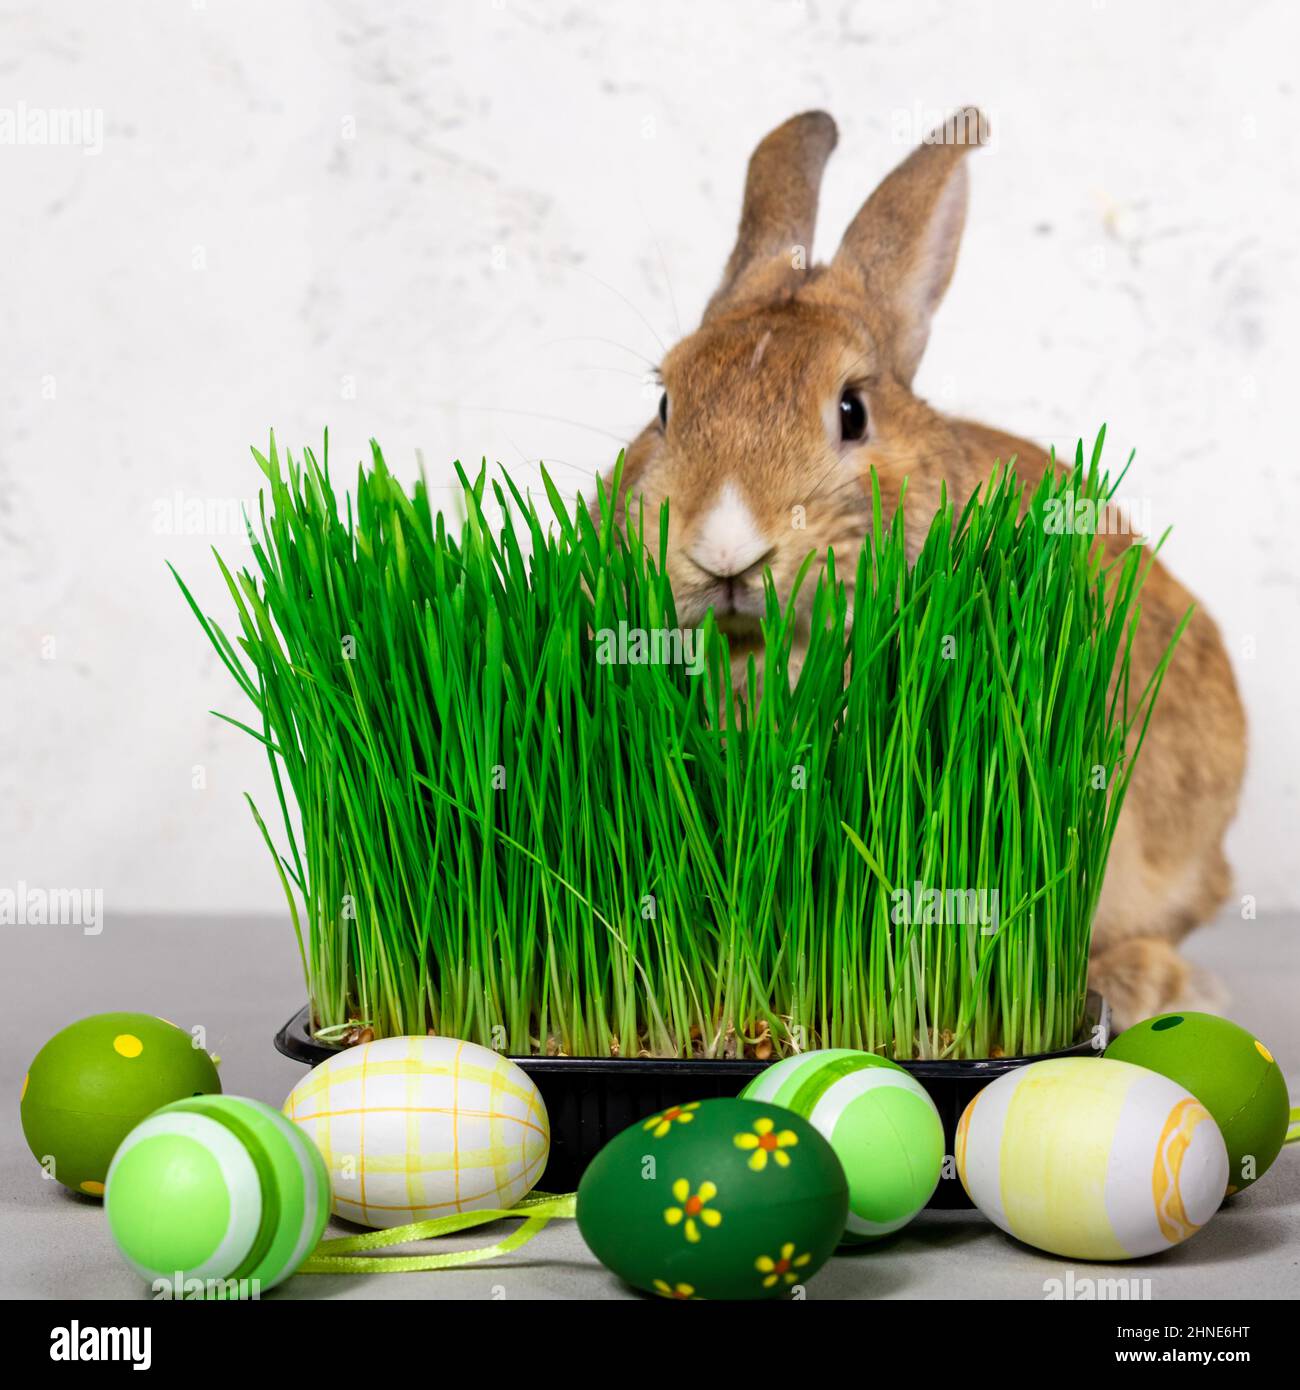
[955,1056,1228,1259]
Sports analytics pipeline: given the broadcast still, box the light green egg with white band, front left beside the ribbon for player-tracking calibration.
[104,1095,330,1298]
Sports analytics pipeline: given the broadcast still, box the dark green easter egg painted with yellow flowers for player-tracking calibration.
[577,1099,848,1298]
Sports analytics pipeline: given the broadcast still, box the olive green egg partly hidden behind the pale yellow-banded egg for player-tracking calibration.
[1105,1013,1290,1195]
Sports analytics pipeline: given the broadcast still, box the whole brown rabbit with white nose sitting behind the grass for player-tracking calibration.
[606,108,1246,1027]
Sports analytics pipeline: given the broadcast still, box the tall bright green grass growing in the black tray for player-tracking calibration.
[178,438,1186,1058]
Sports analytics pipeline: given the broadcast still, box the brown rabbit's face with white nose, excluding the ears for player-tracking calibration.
[628,296,906,637]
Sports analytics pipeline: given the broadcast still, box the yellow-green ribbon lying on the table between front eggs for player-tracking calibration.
[298,1193,577,1275]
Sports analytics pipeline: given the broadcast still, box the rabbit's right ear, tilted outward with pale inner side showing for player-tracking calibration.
[831,106,989,382]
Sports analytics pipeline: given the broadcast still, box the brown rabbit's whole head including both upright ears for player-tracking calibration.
[608,113,987,639]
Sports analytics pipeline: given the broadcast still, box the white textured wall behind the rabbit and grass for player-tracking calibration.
[0,0,1300,912]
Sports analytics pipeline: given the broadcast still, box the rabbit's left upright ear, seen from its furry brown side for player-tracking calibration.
[704,111,837,322]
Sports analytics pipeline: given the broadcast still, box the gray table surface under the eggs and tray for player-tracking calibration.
[0,915,1300,1300]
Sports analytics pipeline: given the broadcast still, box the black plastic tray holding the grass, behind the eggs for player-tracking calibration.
[275,994,1111,1209]
